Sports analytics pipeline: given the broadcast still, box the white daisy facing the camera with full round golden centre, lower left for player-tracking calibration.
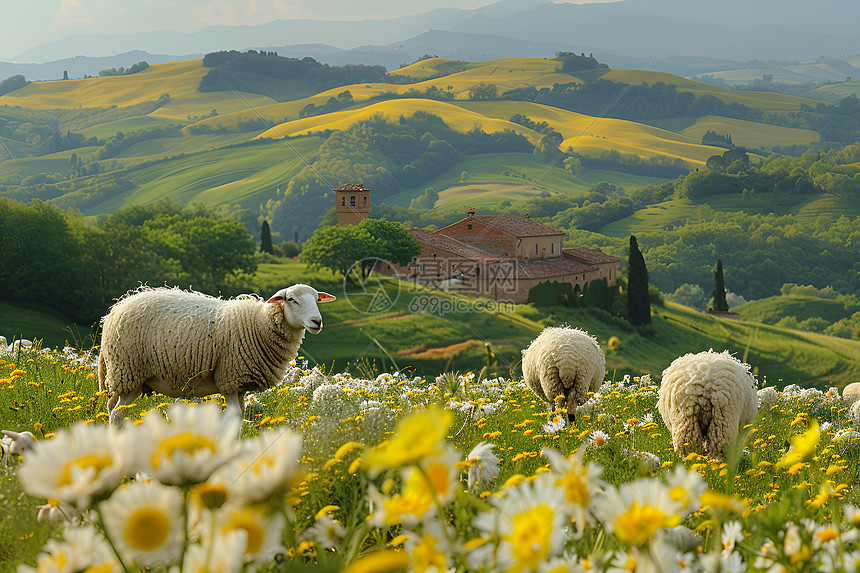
[99,482,183,567]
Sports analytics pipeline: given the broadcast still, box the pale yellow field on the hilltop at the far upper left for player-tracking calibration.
[0,60,274,120]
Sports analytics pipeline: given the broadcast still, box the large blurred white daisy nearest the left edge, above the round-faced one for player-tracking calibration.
[18,423,134,511]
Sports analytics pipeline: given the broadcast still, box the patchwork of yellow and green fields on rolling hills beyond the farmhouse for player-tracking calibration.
[0,52,858,258]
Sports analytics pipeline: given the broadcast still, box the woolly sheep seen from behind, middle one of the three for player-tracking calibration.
[523,326,606,421]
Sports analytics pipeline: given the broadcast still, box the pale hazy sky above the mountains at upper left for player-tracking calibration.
[0,0,620,60]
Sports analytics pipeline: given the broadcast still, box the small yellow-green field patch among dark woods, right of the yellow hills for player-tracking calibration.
[683,115,821,148]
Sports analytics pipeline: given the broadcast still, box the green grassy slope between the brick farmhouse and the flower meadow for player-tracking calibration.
[8,259,860,387]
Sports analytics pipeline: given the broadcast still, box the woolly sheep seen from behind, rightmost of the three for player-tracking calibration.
[657,350,759,458]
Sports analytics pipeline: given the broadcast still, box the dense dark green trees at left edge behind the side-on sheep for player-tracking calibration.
[0,198,257,324]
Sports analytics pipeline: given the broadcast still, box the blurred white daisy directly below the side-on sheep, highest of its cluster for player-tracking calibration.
[139,402,240,485]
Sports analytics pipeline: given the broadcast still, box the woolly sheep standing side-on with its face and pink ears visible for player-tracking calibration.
[99,284,335,424]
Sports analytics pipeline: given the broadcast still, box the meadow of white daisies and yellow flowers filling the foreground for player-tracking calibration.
[0,349,860,573]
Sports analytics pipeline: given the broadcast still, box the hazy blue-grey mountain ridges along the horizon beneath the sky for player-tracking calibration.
[6,0,860,80]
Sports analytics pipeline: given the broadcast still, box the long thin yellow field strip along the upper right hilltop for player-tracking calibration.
[601,70,819,111]
